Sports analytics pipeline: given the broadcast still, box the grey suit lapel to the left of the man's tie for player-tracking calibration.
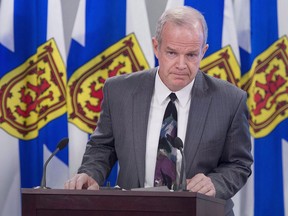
[132,68,157,187]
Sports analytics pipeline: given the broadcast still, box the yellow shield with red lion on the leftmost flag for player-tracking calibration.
[0,39,66,140]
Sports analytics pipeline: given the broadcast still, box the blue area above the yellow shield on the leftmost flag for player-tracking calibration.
[0,0,48,77]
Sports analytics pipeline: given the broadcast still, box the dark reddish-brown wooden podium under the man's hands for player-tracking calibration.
[22,189,225,216]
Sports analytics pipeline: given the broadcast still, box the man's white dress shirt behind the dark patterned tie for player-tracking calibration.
[144,68,194,187]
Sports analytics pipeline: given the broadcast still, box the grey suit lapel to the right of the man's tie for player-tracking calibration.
[184,72,212,171]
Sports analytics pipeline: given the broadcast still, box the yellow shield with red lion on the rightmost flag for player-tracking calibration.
[241,36,288,138]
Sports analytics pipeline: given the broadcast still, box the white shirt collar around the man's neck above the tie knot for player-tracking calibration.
[154,67,195,107]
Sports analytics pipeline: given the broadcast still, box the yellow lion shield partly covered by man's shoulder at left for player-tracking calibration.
[68,34,149,133]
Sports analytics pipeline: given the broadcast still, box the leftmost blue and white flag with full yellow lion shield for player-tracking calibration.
[0,0,68,215]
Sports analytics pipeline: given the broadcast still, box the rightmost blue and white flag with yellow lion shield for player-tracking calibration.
[235,0,288,216]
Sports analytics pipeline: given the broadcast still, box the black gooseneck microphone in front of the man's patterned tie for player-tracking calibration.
[172,137,187,191]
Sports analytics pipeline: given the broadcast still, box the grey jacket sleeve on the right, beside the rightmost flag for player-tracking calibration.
[208,93,253,200]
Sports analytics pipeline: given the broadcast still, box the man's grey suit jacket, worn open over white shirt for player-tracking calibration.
[79,68,253,213]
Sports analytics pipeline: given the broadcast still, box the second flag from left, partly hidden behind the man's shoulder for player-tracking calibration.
[67,0,154,186]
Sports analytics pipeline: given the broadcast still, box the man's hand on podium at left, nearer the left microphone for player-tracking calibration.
[64,173,99,190]
